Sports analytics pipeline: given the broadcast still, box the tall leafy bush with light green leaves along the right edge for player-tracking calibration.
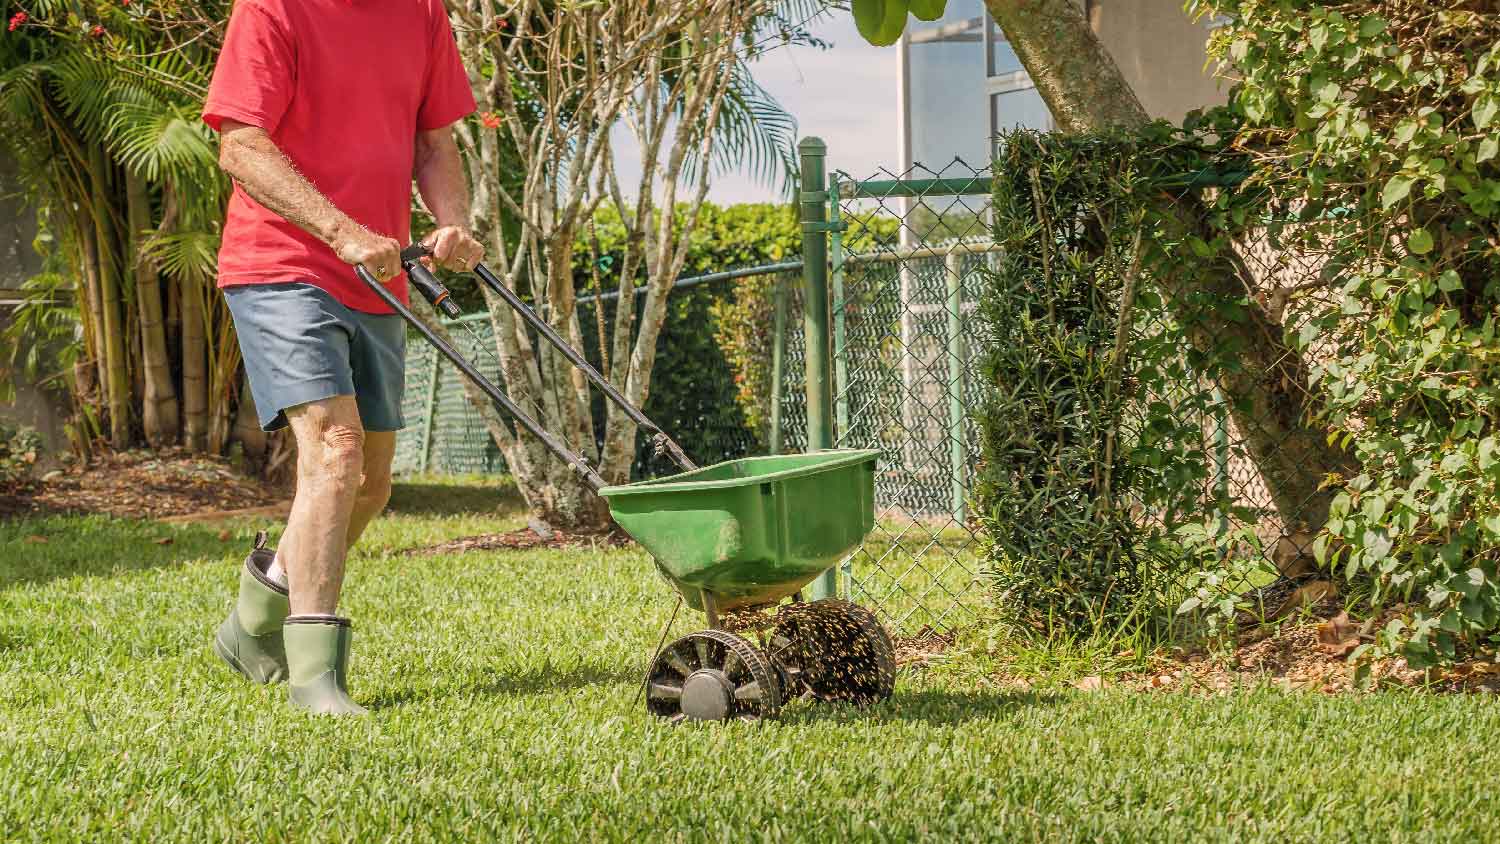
[1193,0,1500,666]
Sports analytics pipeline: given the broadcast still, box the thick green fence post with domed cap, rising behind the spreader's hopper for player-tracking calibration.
[797,138,839,601]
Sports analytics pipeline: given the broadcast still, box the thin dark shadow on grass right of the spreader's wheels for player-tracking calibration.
[782,690,1065,724]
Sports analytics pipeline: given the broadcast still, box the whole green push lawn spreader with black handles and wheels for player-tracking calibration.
[356,244,896,723]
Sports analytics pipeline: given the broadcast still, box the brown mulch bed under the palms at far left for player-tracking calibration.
[0,451,291,519]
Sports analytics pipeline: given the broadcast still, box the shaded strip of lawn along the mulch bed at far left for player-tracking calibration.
[0,516,255,589]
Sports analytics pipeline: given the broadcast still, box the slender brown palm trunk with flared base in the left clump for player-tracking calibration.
[125,172,179,448]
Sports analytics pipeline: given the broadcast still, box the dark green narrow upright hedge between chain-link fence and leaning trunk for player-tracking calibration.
[975,126,1236,631]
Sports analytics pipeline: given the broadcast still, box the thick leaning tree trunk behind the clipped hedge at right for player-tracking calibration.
[986,0,1352,546]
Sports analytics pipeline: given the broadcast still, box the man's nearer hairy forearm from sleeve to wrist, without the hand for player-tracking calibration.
[219,126,359,246]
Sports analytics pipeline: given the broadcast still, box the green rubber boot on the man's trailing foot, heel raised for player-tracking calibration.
[213,534,291,684]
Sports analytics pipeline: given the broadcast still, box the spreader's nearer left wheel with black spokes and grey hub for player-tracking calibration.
[647,630,782,724]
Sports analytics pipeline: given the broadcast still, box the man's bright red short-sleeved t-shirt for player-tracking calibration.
[203,0,474,313]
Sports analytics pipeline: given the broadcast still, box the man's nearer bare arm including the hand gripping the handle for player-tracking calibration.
[219,120,401,282]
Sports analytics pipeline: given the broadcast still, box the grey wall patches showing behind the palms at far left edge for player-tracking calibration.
[0,156,66,448]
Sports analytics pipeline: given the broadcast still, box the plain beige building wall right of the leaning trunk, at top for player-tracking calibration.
[1089,0,1229,123]
